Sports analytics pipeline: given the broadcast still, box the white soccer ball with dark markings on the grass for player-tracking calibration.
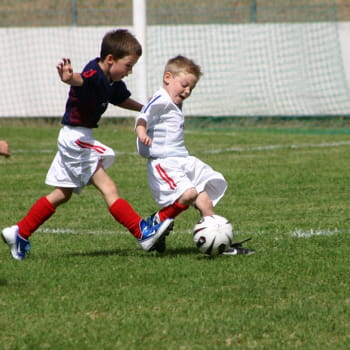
[193,215,233,256]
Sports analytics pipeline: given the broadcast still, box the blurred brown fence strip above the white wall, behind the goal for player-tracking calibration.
[0,0,350,27]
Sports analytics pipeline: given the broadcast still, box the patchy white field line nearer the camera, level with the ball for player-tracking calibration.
[37,228,350,238]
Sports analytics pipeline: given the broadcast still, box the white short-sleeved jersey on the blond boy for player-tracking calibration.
[136,88,189,158]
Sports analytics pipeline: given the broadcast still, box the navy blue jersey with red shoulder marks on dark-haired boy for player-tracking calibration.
[62,57,131,128]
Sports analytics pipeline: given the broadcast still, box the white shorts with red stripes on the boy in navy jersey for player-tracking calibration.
[45,126,115,193]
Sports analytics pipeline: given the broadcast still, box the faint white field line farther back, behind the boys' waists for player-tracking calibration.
[12,141,350,156]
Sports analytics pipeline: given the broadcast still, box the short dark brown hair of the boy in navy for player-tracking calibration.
[100,29,142,60]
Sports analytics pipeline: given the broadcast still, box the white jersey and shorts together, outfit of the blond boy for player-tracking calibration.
[136,88,227,207]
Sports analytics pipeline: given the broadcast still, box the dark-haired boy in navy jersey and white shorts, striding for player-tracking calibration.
[2,29,172,260]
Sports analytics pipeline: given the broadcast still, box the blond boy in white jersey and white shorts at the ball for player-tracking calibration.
[135,55,254,255]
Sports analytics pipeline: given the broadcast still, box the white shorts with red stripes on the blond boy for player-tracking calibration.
[147,156,227,207]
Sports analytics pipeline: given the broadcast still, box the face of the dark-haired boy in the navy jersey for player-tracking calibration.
[104,55,139,82]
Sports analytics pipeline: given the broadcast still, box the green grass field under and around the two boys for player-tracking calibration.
[0,121,350,350]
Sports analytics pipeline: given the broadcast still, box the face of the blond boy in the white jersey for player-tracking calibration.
[164,72,198,106]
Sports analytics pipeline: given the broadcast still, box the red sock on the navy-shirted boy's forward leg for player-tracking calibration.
[109,198,142,238]
